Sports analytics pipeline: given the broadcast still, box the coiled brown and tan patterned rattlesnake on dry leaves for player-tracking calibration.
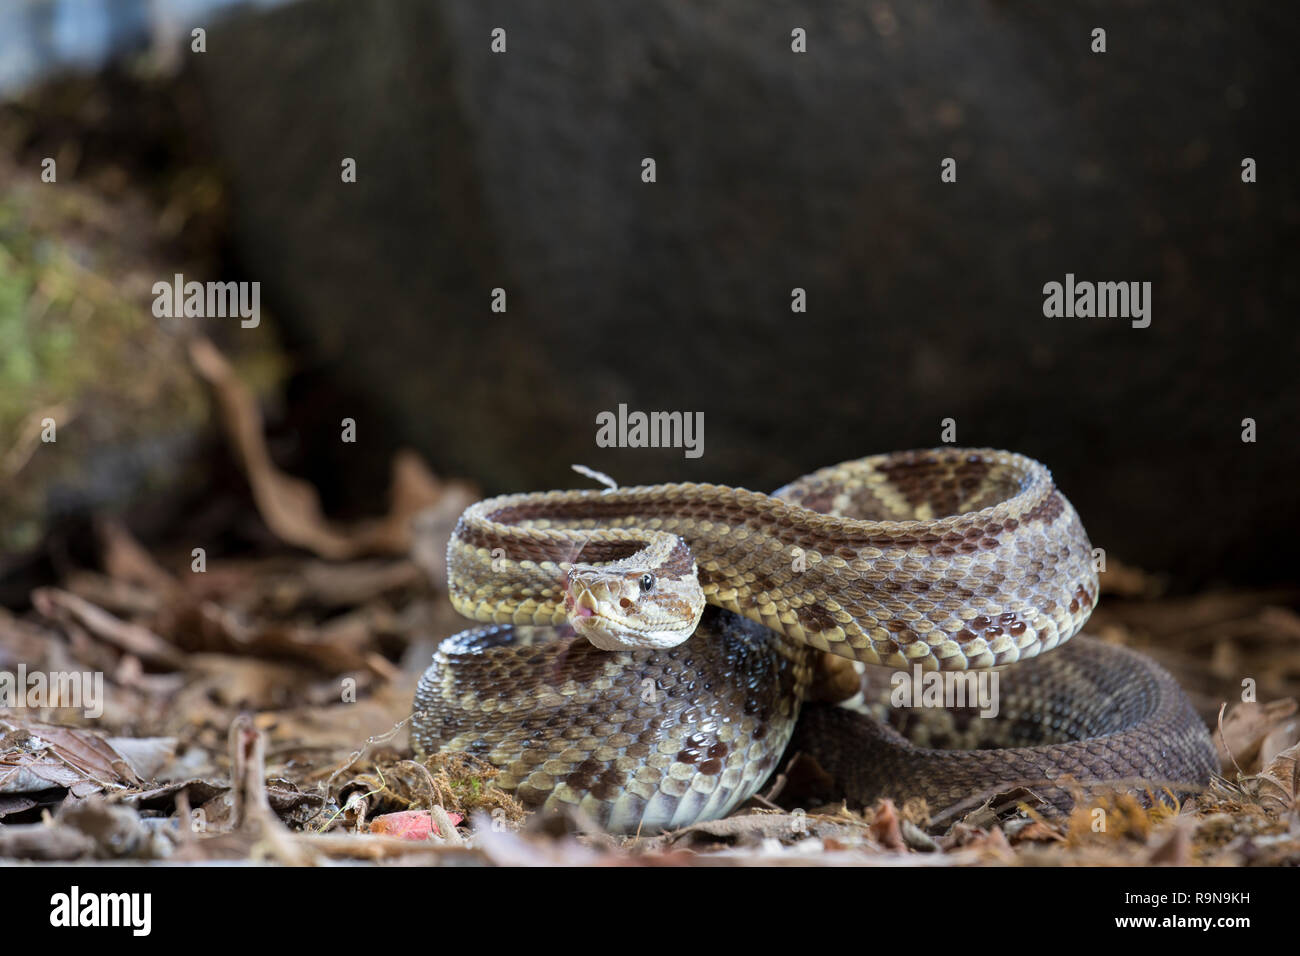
[412,447,1217,832]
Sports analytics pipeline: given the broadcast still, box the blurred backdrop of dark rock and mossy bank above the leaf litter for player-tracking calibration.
[0,0,1300,602]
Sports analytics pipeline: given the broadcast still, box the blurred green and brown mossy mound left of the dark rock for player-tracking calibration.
[0,169,283,553]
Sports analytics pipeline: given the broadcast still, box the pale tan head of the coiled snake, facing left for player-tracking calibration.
[564,544,705,650]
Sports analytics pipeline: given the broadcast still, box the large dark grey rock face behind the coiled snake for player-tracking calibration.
[192,0,1300,583]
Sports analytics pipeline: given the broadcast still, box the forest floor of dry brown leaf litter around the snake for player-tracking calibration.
[0,339,1300,866]
